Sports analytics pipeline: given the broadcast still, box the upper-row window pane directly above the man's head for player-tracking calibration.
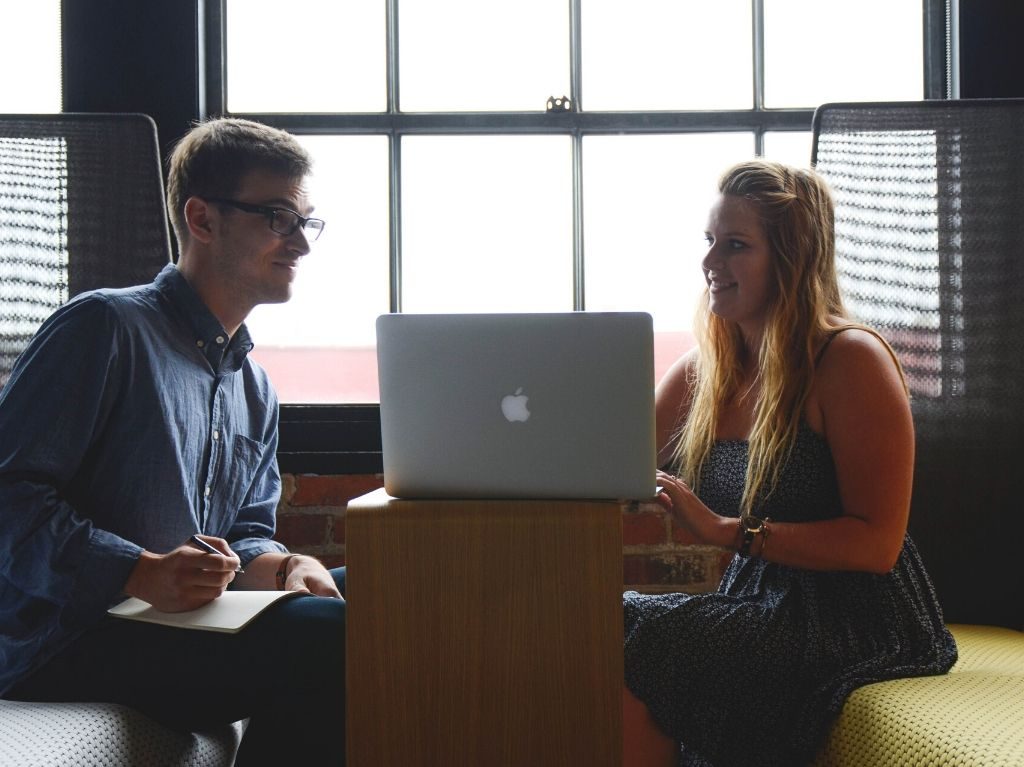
[225,0,387,113]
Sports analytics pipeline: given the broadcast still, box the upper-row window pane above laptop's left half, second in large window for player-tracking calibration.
[397,0,569,112]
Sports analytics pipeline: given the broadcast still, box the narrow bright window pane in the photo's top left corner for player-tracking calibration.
[0,0,60,114]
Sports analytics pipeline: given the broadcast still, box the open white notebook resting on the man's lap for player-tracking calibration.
[106,591,303,634]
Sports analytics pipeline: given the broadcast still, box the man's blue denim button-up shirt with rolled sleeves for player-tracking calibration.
[0,265,285,694]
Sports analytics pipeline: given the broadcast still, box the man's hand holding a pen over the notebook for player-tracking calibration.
[124,537,240,612]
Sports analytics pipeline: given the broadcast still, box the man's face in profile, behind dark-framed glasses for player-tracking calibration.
[211,170,312,313]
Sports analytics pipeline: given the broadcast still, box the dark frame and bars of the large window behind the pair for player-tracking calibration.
[205,0,956,474]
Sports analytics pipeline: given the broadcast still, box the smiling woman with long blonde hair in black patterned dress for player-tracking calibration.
[624,161,956,767]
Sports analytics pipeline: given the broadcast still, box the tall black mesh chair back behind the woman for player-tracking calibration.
[812,99,1024,629]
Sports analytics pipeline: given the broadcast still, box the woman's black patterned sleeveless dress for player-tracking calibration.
[624,424,956,767]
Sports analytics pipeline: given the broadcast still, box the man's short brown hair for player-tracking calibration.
[167,118,312,245]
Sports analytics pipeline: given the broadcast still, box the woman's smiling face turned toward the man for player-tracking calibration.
[700,195,774,335]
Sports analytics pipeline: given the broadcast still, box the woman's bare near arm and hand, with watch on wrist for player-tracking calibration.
[658,330,913,573]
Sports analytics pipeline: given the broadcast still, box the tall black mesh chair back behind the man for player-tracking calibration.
[0,114,171,387]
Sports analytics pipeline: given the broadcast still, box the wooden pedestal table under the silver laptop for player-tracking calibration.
[345,491,623,767]
